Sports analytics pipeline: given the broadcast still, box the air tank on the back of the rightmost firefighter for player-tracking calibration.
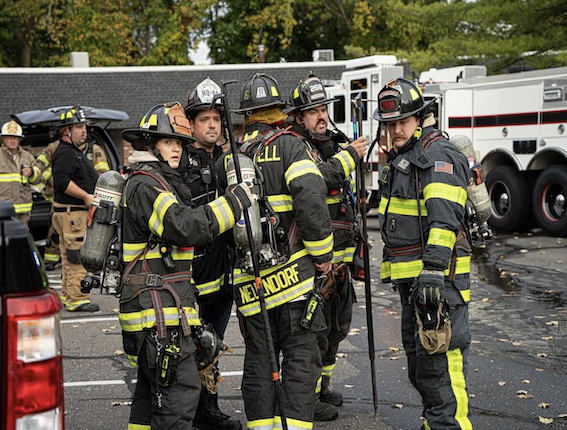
[450,135,491,224]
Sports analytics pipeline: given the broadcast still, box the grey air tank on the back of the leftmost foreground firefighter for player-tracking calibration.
[81,170,125,273]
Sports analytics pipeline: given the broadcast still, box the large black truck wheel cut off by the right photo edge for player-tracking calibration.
[533,166,567,236]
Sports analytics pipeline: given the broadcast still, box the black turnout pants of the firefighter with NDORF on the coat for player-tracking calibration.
[238,300,325,430]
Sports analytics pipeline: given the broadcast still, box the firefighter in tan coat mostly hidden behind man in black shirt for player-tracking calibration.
[33,127,110,270]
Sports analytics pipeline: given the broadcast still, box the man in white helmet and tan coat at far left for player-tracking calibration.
[0,120,40,226]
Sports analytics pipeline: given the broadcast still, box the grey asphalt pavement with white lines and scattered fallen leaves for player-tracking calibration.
[53,214,567,430]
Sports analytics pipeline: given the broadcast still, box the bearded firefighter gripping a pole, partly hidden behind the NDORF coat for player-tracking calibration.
[288,73,366,421]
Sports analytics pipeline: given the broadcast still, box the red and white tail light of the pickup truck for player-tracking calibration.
[2,290,64,430]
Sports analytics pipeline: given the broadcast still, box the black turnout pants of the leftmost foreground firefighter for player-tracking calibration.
[128,327,201,430]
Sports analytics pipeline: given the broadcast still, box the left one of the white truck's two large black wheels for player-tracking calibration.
[486,166,531,232]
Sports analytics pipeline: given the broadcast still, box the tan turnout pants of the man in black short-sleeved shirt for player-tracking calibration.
[51,203,90,310]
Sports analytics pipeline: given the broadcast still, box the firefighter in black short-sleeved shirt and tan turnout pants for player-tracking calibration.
[51,107,99,312]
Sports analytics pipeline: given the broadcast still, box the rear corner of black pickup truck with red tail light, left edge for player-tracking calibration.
[0,202,65,430]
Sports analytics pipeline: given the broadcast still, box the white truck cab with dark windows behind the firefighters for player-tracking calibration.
[325,55,404,207]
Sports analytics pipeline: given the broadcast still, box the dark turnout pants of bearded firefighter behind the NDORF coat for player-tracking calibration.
[315,273,356,393]
